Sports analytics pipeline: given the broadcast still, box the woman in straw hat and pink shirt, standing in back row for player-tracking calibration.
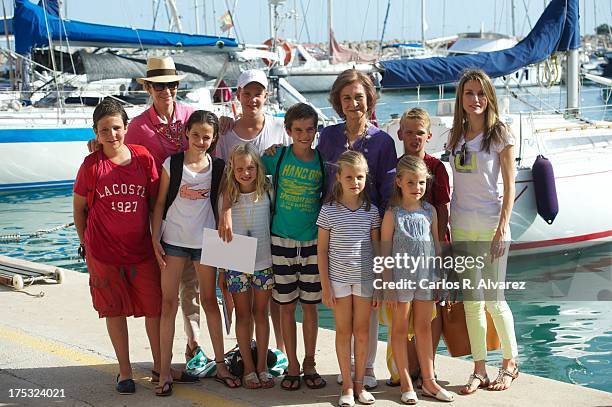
[125,57,204,383]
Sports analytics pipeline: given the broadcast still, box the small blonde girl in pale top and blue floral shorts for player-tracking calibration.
[219,143,274,389]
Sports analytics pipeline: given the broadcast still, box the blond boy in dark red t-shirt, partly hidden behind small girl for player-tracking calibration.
[387,107,450,386]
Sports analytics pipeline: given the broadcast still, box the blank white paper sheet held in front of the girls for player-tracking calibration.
[200,229,257,274]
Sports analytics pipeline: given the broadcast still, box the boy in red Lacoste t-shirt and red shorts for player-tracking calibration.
[74,99,161,394]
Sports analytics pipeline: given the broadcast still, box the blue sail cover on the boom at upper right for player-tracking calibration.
[380,0,580,89]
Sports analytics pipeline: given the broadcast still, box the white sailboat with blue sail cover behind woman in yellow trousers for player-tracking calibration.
[381,0,612,256]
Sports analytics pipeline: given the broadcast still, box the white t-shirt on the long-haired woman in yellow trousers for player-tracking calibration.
[450,132,514,230]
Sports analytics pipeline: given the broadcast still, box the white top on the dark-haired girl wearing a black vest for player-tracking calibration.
[162,154,215,249]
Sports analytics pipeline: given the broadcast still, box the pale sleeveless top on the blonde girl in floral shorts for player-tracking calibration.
[219,191,273,271]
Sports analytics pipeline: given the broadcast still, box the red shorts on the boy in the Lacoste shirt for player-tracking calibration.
[87,254,161,318]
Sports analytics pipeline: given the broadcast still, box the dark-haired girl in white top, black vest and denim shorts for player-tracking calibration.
[151,110,240,396]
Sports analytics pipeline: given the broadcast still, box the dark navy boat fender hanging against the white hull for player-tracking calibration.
[531,155,559,225]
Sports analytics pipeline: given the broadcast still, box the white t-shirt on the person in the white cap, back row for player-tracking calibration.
[215,114,291,162]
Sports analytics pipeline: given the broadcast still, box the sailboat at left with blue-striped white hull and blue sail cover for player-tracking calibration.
[0,0,241,191]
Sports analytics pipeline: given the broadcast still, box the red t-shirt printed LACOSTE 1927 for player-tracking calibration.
[74,145,158,265]
